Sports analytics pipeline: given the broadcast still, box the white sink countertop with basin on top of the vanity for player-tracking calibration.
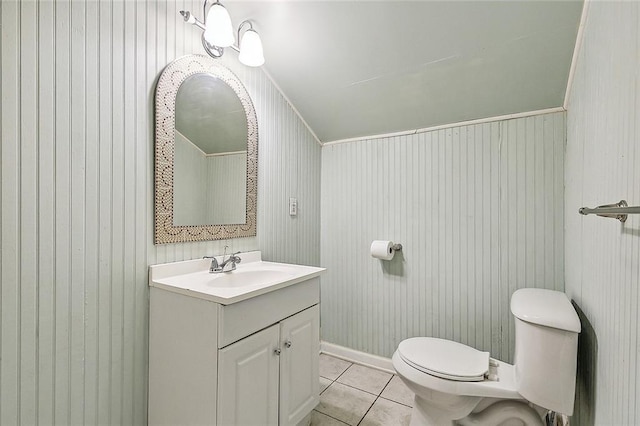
[149,251,325,305]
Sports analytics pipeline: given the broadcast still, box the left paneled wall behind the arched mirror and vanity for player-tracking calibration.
[0,0,320,425]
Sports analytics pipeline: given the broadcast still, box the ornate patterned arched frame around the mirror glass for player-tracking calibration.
[155,55,258,244]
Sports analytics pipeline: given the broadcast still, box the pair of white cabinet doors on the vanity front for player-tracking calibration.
[218,305,319,425]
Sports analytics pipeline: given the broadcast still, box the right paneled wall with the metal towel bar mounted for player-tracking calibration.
[565,1,640,425]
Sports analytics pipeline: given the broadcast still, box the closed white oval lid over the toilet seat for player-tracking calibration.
[398,337,489,382]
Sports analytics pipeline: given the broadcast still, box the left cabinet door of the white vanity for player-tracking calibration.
[218,324,280,426]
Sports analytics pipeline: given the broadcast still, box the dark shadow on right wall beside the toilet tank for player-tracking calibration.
[571,301,598,426]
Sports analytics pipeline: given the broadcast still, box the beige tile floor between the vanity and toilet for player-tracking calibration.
[311,354,413,426]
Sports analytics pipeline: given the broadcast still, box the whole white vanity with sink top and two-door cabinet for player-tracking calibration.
[149,252,324,425]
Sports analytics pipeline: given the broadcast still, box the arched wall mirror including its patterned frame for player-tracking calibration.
[155,55,258,244]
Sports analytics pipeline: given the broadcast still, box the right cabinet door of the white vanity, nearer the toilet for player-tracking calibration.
[280,305,320,425]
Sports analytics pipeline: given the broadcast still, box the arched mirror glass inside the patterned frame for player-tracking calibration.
[173,73,247,226]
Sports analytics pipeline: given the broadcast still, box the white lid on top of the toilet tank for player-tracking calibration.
[511,288,580,333]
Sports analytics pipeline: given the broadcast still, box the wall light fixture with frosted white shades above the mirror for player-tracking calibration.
[180,0,264,67]
